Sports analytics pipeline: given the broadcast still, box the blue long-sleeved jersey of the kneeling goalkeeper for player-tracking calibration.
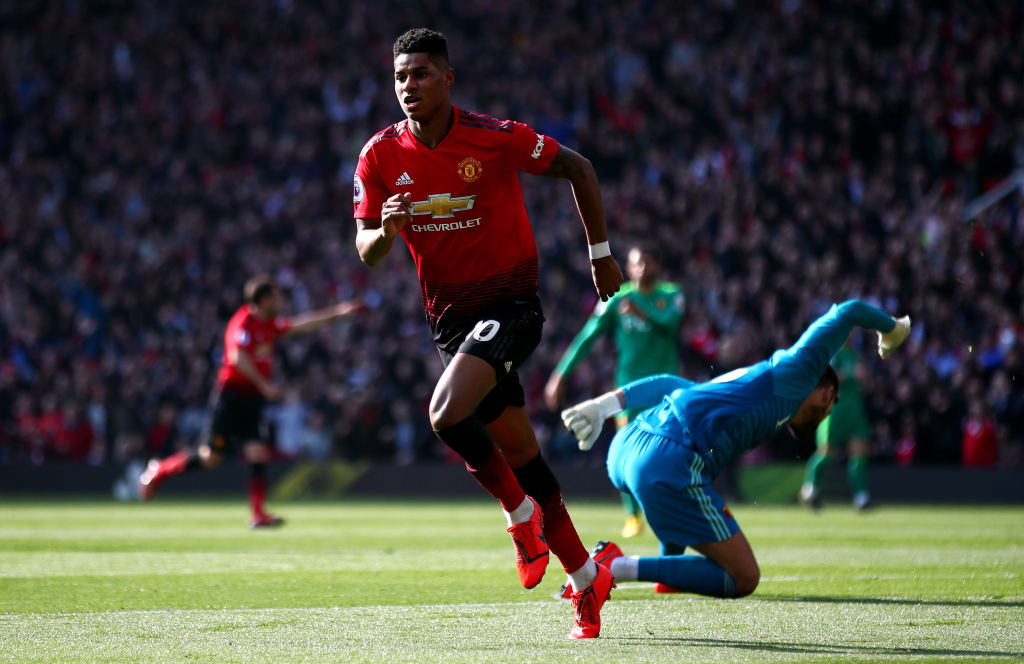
[624,300,895,478]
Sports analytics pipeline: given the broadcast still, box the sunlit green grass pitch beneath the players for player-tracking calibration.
[0,496,1024,664]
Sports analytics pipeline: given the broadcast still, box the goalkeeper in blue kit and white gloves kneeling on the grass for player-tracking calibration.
[562,300,910,597]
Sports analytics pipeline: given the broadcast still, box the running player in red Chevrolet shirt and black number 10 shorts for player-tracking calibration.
[353,28,623,638]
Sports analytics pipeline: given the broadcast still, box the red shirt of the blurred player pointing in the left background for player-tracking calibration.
[217,304,292,395]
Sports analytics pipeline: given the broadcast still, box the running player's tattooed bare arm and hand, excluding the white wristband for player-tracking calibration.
[543,146,623,300]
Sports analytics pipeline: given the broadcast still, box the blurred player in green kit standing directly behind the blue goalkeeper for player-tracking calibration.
[544,243,686,537]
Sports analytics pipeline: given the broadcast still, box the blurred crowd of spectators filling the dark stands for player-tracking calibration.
[0,0,1024,465]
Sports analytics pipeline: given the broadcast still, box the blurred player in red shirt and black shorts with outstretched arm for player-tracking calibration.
[138,277,362,528]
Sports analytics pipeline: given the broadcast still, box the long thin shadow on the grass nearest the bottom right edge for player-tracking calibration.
[602,631,1024,659]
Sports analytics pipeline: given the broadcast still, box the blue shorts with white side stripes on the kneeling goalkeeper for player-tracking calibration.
[607,420,739,549]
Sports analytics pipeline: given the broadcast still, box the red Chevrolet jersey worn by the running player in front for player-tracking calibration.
[353,107,558,336]
